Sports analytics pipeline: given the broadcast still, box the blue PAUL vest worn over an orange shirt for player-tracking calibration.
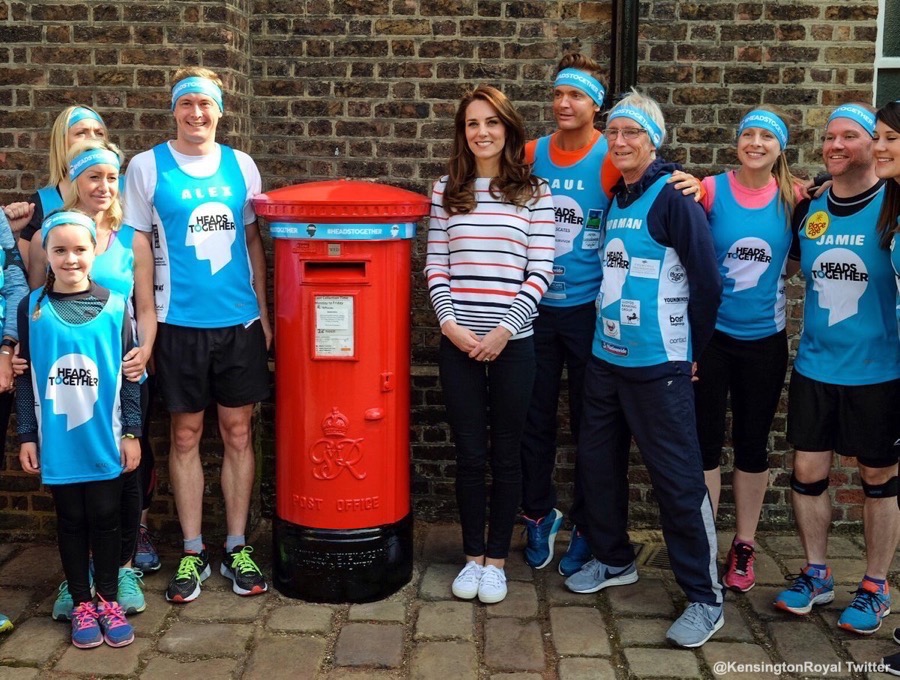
[533,137,609,307]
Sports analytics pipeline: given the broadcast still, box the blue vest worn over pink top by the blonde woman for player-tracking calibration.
[709,174,792,340]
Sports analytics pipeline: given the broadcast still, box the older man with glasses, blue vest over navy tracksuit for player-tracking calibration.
[566,91,724,647]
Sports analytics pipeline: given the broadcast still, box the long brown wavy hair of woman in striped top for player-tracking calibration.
[444,85,539,215]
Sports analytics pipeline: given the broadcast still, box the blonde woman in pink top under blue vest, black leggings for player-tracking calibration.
[694,108,800,592]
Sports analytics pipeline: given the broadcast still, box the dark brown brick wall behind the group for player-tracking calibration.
[0,0,877,536]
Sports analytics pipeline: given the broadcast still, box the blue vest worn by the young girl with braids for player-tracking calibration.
[28,290,125,484]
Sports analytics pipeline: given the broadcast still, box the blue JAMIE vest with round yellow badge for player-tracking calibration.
[794,189,900,385]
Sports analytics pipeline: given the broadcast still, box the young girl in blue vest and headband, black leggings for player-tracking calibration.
[16,211,141,649]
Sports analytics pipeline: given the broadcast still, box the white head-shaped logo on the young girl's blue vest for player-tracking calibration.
[44,354,100,430]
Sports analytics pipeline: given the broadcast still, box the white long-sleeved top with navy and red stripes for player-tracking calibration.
[425,177,556,339]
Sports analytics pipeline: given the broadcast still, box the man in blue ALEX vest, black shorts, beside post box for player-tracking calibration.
[125,67,272,602]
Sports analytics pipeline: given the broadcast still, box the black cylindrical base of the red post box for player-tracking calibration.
[272,512,413,603]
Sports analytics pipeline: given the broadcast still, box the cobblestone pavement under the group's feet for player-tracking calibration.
[0,523,900,680]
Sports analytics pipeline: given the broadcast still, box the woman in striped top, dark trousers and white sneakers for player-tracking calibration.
[425,85,555,602]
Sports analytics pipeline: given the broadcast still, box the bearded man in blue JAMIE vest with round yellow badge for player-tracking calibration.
[775,104,900,635]
